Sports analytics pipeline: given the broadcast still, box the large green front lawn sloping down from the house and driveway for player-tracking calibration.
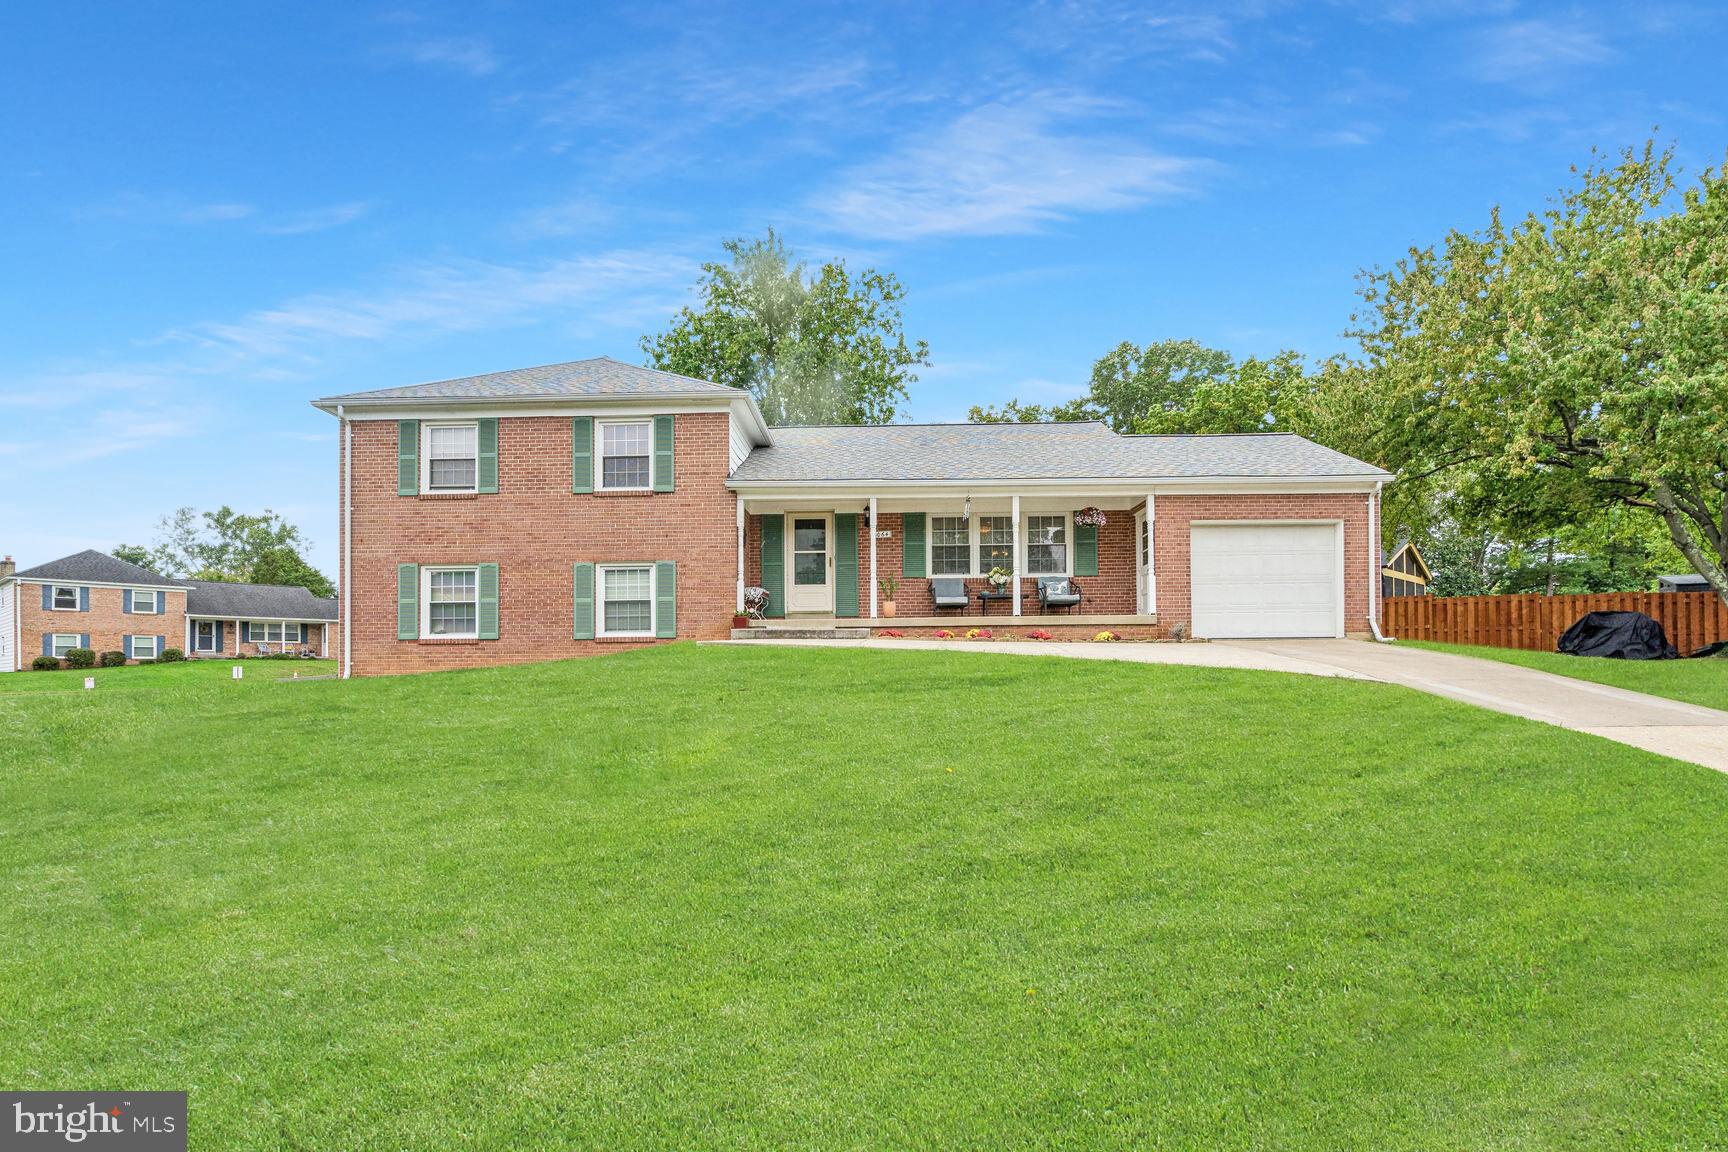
[0,644,1728,1150]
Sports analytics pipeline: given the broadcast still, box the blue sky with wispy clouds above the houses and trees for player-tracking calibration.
[0,0,1728,573]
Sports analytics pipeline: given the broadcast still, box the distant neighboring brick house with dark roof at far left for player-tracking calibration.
[0,551,337,672]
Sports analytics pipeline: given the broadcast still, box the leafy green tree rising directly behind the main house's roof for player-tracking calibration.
[641,228,930,425]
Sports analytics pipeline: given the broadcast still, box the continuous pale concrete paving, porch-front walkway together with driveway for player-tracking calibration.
[719,639,1728,772]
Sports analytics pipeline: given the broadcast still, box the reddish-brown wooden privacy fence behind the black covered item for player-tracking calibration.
[1381,592,1728,656]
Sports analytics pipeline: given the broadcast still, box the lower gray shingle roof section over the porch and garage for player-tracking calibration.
[733,421,1388,484]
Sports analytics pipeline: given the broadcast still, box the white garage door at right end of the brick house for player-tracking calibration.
[1189,523,1344,639]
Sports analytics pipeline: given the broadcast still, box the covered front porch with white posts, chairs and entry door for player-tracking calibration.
[738,491,1158,636]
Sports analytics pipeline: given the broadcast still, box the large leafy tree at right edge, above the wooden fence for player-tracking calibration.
[1356,143,1728,601]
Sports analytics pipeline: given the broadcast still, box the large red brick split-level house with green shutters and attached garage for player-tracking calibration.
[314,358,1391,675]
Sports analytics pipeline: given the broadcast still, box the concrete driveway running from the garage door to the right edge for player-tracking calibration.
[1230,641,1728,772]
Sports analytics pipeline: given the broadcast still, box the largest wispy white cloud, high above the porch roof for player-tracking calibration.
[810,93,1206,240]
